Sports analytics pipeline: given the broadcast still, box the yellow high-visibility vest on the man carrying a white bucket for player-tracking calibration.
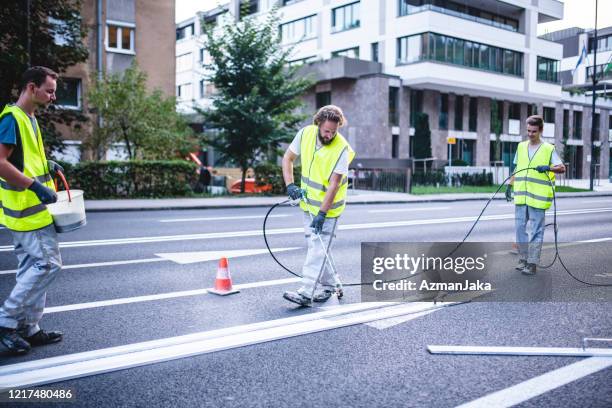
[0,105,55,231]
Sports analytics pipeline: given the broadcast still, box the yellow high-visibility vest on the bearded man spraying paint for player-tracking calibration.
[300,125,355,218]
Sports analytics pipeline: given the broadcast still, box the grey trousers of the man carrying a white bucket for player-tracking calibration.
[0,224,62,336]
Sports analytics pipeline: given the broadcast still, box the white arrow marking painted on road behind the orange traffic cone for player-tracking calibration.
[0,247,300,275]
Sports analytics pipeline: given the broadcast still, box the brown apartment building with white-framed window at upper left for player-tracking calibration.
[56,0,176,162]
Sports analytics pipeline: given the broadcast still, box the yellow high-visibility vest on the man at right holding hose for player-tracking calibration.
[514,140,555,210]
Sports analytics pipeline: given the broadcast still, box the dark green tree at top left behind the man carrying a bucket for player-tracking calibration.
[0,0,88,155]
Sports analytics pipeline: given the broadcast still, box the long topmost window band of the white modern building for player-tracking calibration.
[398,0,518,32]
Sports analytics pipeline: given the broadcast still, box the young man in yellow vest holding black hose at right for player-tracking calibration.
[506,115,565,275]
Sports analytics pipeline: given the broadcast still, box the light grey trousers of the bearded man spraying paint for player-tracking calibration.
[298,212,340,298]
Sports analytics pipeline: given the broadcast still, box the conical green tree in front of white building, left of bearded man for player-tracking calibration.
[199,6,313,191]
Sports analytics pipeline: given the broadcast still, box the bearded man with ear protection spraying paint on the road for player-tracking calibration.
[282,105,355,306]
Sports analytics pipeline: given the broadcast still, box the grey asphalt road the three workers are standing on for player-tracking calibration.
[0,197,612,407]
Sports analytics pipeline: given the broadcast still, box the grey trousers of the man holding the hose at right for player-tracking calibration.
[514,205,546,264]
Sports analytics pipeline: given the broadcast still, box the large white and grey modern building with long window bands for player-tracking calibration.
[177,0,610,177]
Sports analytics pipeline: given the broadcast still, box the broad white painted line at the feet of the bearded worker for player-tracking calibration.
[0,303,451,391]
